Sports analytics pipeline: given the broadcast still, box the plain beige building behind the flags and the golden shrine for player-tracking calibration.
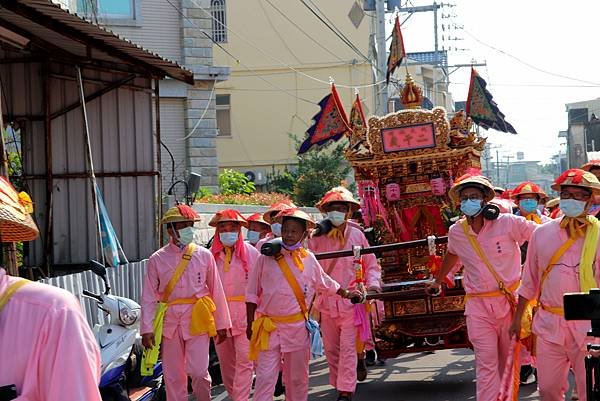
[214,0,446,185]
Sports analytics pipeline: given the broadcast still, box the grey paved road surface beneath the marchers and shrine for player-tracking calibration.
[205,349,571,401]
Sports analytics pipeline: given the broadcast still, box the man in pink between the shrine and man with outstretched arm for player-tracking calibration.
[308,187,381,400]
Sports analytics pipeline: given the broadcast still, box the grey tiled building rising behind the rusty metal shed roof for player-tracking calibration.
[65,0,229,191]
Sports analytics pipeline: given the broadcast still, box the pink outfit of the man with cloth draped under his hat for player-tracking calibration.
[216,242,260,401]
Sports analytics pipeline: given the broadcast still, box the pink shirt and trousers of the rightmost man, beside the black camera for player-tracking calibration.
[519,219,600,401]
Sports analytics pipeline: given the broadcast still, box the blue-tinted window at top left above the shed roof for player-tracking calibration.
[77,0,140,25]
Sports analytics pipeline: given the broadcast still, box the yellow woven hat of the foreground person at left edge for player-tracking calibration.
[0,177,39,242]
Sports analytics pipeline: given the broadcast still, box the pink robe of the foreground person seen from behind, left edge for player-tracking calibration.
[0,269,101,401]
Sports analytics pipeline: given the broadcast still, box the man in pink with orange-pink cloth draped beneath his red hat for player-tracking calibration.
[209,209,260,401]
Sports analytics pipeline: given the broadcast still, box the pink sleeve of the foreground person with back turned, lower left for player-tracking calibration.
[36,299,101,401]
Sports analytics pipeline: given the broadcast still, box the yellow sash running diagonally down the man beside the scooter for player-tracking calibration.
[141,243,202,376]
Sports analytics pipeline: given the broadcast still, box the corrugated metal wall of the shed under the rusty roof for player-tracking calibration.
[0,53,156,266]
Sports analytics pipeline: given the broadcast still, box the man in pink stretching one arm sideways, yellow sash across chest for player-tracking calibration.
[246,209,361,401]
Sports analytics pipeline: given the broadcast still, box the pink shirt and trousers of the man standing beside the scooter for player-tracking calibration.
[140,242,231,401]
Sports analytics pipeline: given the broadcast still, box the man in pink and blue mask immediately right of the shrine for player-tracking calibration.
[430,175,537,401]
